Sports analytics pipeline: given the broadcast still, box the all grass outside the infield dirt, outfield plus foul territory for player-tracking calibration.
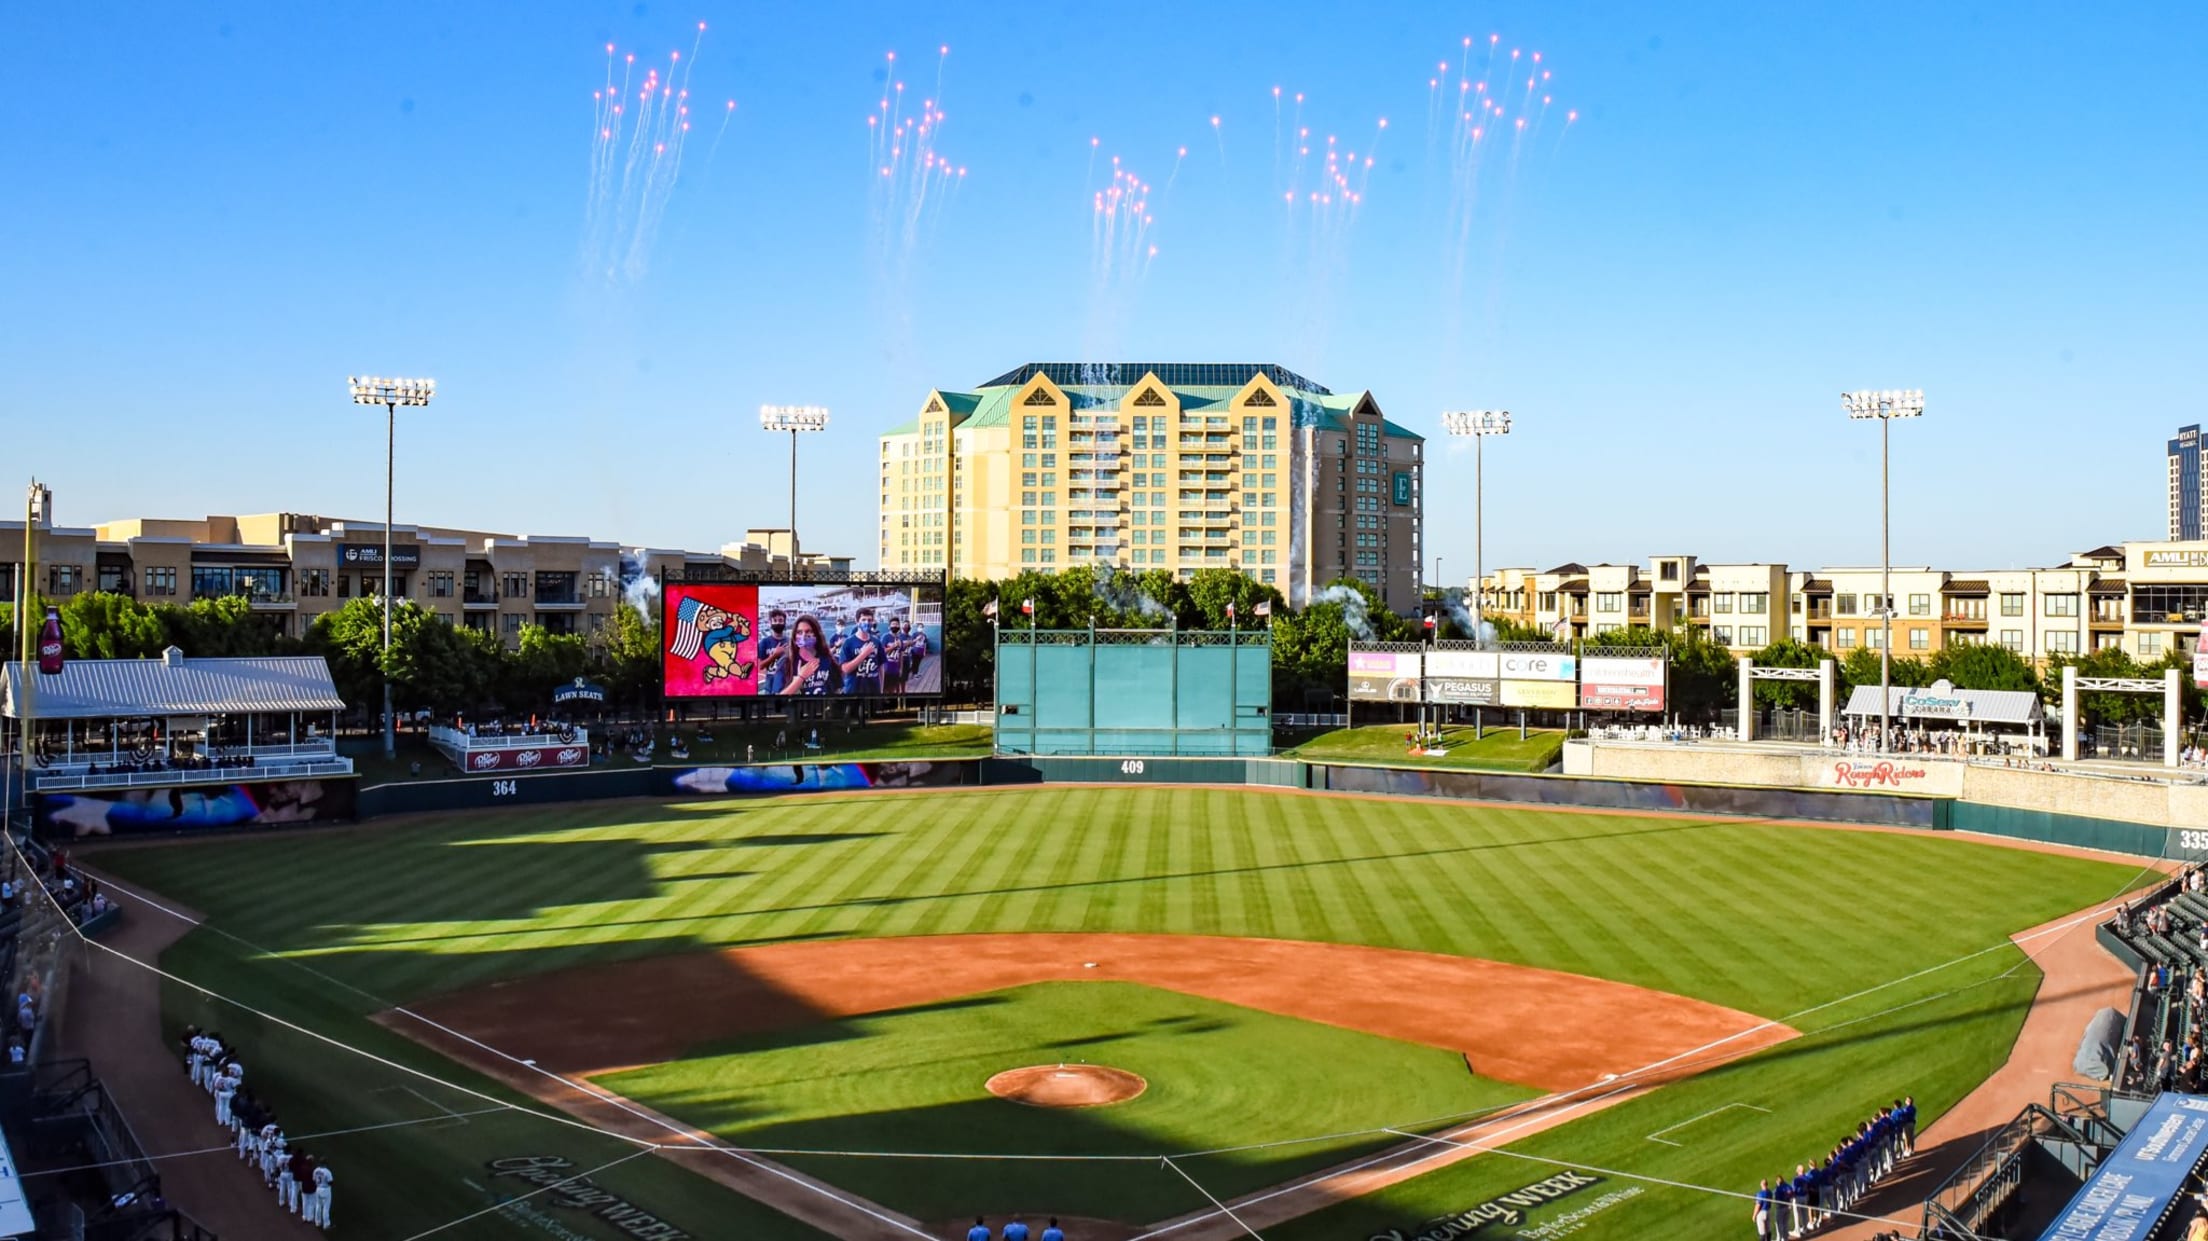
[97,788,2146,1241]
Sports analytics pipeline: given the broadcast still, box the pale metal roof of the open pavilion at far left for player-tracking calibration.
[0,647,344,720]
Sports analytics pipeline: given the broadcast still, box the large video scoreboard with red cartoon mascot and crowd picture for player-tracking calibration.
[660,583,943,698]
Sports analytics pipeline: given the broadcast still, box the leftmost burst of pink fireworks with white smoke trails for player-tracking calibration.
[583,22,735,283]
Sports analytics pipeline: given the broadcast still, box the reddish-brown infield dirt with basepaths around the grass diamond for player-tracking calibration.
[378,934,1795,1241]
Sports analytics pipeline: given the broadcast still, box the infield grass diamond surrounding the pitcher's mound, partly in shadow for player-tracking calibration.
[598,983,1537,1223]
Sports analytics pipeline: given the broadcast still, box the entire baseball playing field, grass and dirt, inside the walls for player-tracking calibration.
[93,786,2148,1241]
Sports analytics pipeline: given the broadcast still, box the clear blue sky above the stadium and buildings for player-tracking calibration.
[0,0,2208,579]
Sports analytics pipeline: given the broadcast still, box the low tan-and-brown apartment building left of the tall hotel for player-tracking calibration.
[0,488,850,640]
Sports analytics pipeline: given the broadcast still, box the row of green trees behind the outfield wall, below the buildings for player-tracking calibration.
[0,565,2204,724]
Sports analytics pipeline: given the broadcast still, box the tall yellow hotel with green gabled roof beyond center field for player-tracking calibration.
[879,362,1424,612]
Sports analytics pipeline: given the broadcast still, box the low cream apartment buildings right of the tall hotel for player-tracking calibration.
[1468,541,2208,662]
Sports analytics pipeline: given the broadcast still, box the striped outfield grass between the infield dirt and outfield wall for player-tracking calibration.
[104,788,2135,1016]
